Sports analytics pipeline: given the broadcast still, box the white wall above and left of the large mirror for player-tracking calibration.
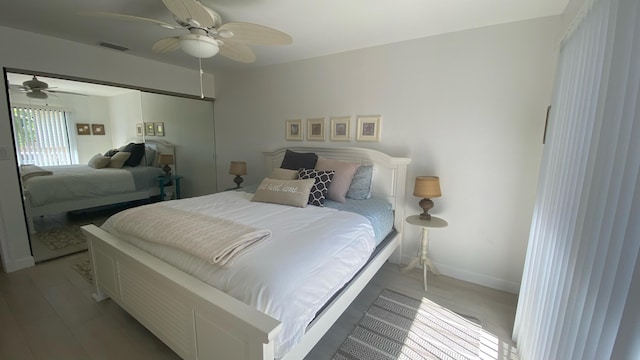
[0,27,215,271]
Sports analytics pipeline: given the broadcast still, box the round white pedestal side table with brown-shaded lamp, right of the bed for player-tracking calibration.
[400,176,448,291]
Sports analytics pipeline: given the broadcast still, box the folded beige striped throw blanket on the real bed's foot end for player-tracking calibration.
[105,203,271,266]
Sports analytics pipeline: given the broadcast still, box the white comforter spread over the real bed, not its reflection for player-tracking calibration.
[103,191,375,357]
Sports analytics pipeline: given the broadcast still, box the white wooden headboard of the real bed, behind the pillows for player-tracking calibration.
[264,147,411,238]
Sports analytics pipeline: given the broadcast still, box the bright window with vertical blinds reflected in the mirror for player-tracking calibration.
[11,106,71,166]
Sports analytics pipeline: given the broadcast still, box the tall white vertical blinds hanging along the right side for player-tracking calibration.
[513,0,640,360]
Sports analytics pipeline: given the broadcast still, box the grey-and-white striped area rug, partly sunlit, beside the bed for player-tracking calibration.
[333,289,503,360]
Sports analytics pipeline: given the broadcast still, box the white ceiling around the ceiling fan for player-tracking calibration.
[0,0,569,73]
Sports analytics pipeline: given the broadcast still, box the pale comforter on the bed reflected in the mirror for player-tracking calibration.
[24,165,136,206]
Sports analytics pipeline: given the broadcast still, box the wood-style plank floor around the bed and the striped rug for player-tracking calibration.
[0,253,517,360]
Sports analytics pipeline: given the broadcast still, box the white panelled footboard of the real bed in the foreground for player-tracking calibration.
[82,225,281,360]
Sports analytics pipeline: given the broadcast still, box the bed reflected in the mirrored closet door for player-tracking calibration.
[21,139,175,231]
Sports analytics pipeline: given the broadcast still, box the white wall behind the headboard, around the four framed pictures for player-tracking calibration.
[215,16,561,292]
